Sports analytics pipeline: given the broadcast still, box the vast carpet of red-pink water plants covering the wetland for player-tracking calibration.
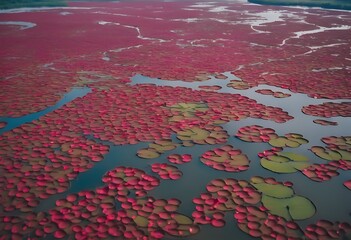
[0,1,351,239]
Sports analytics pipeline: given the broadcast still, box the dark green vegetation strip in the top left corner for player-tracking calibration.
[0,0,66,9]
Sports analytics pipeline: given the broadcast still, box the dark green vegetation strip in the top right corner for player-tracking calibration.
[248,0,351,10]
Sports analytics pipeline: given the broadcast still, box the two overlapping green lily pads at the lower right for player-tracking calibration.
[250,177,316,221]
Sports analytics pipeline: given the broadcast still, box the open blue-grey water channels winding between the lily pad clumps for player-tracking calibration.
[0,72,351,240]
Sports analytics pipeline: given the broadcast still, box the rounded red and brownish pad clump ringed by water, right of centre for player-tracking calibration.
[200,145,250,172]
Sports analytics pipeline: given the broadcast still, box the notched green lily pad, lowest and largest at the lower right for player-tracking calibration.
[262,195,316,220]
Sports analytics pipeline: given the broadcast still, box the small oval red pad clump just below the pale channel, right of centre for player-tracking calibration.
[235,125,278,143]
